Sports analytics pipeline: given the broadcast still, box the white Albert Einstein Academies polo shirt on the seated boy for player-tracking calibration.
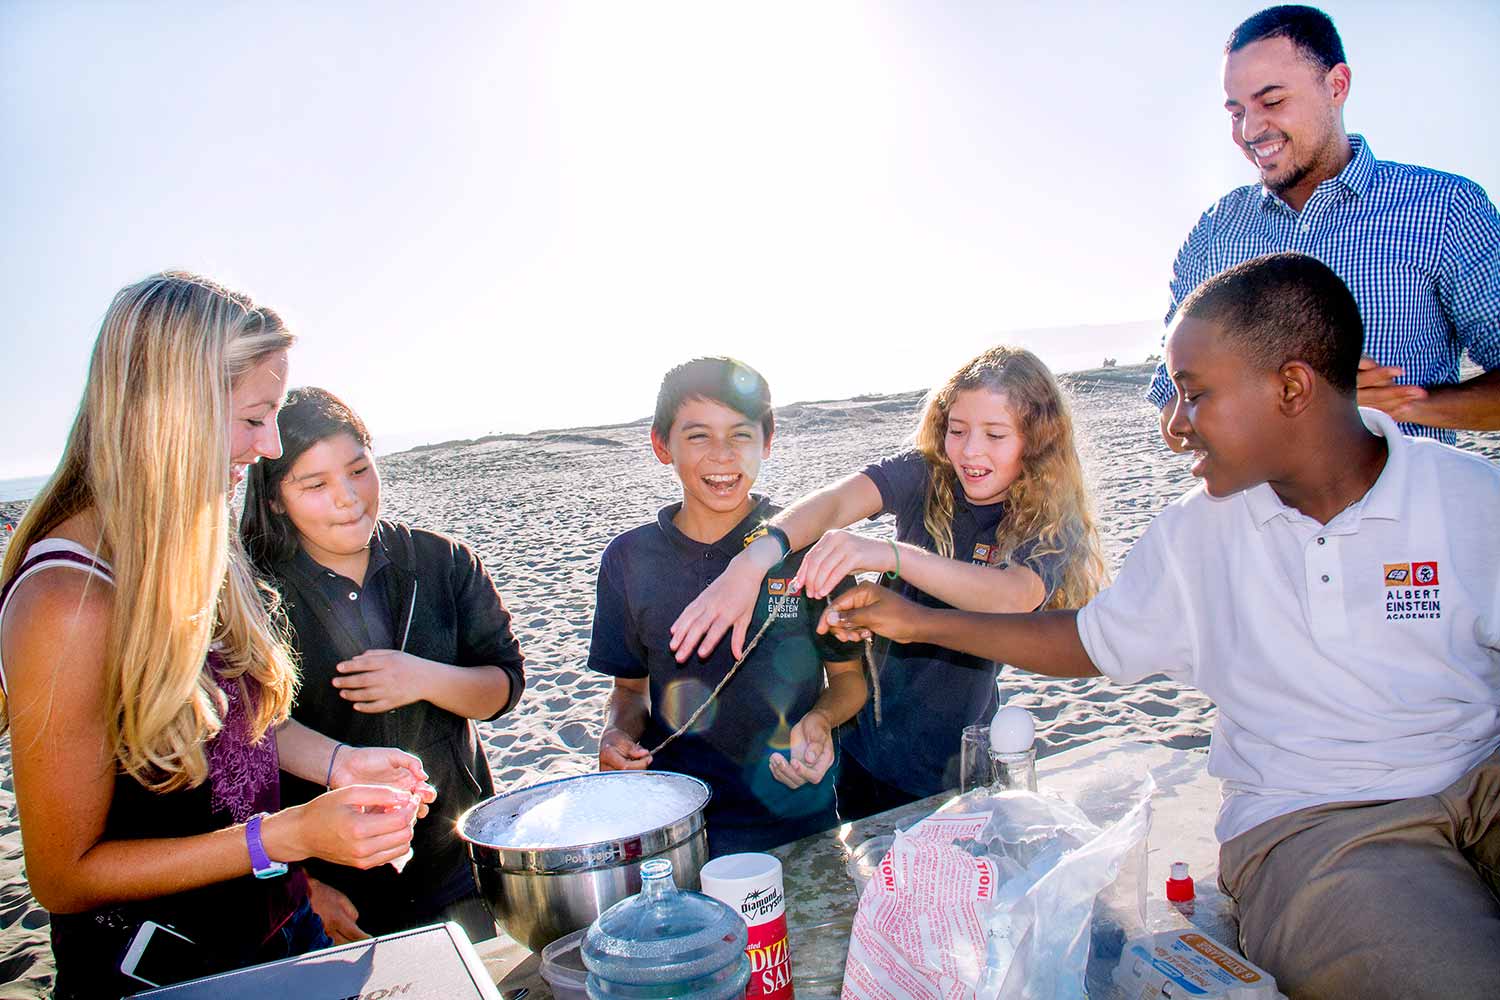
[1079,409,1500,843]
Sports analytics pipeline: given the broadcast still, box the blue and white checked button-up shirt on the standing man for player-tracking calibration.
[1148,135,1500,444]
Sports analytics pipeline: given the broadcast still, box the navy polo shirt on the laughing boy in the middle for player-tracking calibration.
[588,496,861,853]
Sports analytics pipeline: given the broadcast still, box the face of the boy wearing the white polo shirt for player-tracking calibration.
[1167,316,1286,496]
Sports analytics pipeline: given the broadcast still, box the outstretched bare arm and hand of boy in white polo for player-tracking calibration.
[818,583,1100,678]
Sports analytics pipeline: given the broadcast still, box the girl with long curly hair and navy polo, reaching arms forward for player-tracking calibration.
[672,346,1104,820]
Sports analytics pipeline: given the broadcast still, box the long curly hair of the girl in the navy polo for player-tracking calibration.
[915,346,1106,609]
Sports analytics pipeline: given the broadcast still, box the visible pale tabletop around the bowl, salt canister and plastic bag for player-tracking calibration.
[477,741,1238,1000]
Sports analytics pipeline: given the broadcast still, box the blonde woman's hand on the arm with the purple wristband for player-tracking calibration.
[261,784,420,868]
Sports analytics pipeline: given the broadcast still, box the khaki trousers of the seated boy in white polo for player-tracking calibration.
[1220,753,1500,1000]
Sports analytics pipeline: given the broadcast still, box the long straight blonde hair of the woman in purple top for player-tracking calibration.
[0,271,297,792]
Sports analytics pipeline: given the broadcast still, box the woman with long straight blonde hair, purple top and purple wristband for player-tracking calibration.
[0,273,432,999]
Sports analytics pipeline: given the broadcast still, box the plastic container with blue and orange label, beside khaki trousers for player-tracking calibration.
[1115,931,1283,1000]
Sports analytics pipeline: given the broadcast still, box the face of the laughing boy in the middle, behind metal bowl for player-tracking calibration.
[651,399,771,516]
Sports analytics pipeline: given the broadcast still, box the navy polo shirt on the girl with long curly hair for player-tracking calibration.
[840,451,1059,798]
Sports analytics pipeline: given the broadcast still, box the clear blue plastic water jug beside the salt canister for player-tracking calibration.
[584,858,750,1000]
